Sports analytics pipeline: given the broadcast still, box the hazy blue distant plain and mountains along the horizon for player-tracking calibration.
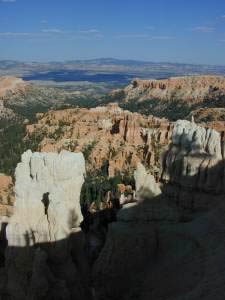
[0,58,225,85]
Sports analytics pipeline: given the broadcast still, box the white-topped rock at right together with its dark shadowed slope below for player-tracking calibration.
[93,121,225,300]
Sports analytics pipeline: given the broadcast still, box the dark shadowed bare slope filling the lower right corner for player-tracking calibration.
[94,203,225,300]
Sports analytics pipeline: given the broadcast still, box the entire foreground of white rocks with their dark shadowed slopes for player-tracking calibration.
[1,120,225,300]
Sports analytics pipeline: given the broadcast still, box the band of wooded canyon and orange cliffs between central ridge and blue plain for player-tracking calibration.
[0,75,225,124]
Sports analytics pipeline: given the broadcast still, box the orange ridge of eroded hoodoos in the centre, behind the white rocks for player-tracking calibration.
[27,104,172,177]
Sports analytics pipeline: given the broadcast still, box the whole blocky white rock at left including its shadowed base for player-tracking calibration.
[6,151,89,299]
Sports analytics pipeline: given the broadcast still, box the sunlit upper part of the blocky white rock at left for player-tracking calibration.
[7,151,85,247]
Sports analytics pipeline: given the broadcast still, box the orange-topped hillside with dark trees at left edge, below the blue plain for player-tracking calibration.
[0,76,82,126]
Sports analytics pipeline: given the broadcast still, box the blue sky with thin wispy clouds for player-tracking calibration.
[0,0,225,65]
